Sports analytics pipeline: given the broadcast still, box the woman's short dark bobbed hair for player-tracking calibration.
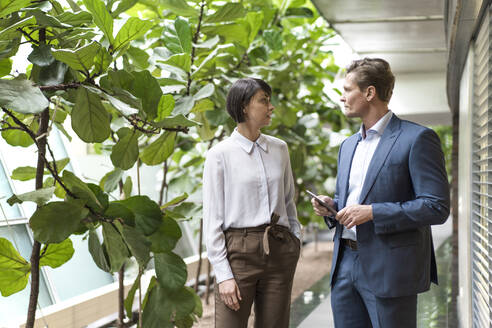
[226,77,272,123]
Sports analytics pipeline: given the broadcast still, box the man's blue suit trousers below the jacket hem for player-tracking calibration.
[331,246,417,328]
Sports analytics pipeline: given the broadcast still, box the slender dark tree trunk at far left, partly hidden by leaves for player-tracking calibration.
[26,108,50,328]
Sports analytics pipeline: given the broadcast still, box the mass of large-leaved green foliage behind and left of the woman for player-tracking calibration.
[0,0,351,327]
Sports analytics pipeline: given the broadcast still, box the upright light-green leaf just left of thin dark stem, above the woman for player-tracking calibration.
[163,17,191,54]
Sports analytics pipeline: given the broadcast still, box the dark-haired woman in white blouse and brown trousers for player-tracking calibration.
[203,78,300,328]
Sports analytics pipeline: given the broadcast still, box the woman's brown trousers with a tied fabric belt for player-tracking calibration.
[215,225,300,328]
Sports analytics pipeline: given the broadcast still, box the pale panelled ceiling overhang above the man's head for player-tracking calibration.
[313,0,447,73]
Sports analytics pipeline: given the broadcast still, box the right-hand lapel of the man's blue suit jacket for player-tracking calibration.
[359,114,401,204]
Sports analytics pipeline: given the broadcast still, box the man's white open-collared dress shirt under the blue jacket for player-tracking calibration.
[342,111,393,240]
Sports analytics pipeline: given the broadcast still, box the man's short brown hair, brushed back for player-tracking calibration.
[347,58,395,102]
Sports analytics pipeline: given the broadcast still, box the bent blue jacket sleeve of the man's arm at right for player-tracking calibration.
[372,129,450,234]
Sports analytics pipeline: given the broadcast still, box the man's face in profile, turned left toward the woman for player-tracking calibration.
[340,72,369,117]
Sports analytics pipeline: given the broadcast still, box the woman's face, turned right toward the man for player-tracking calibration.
[244,90,275,129]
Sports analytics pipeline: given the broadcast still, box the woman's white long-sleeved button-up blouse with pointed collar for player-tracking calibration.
[203,129,300,283]
